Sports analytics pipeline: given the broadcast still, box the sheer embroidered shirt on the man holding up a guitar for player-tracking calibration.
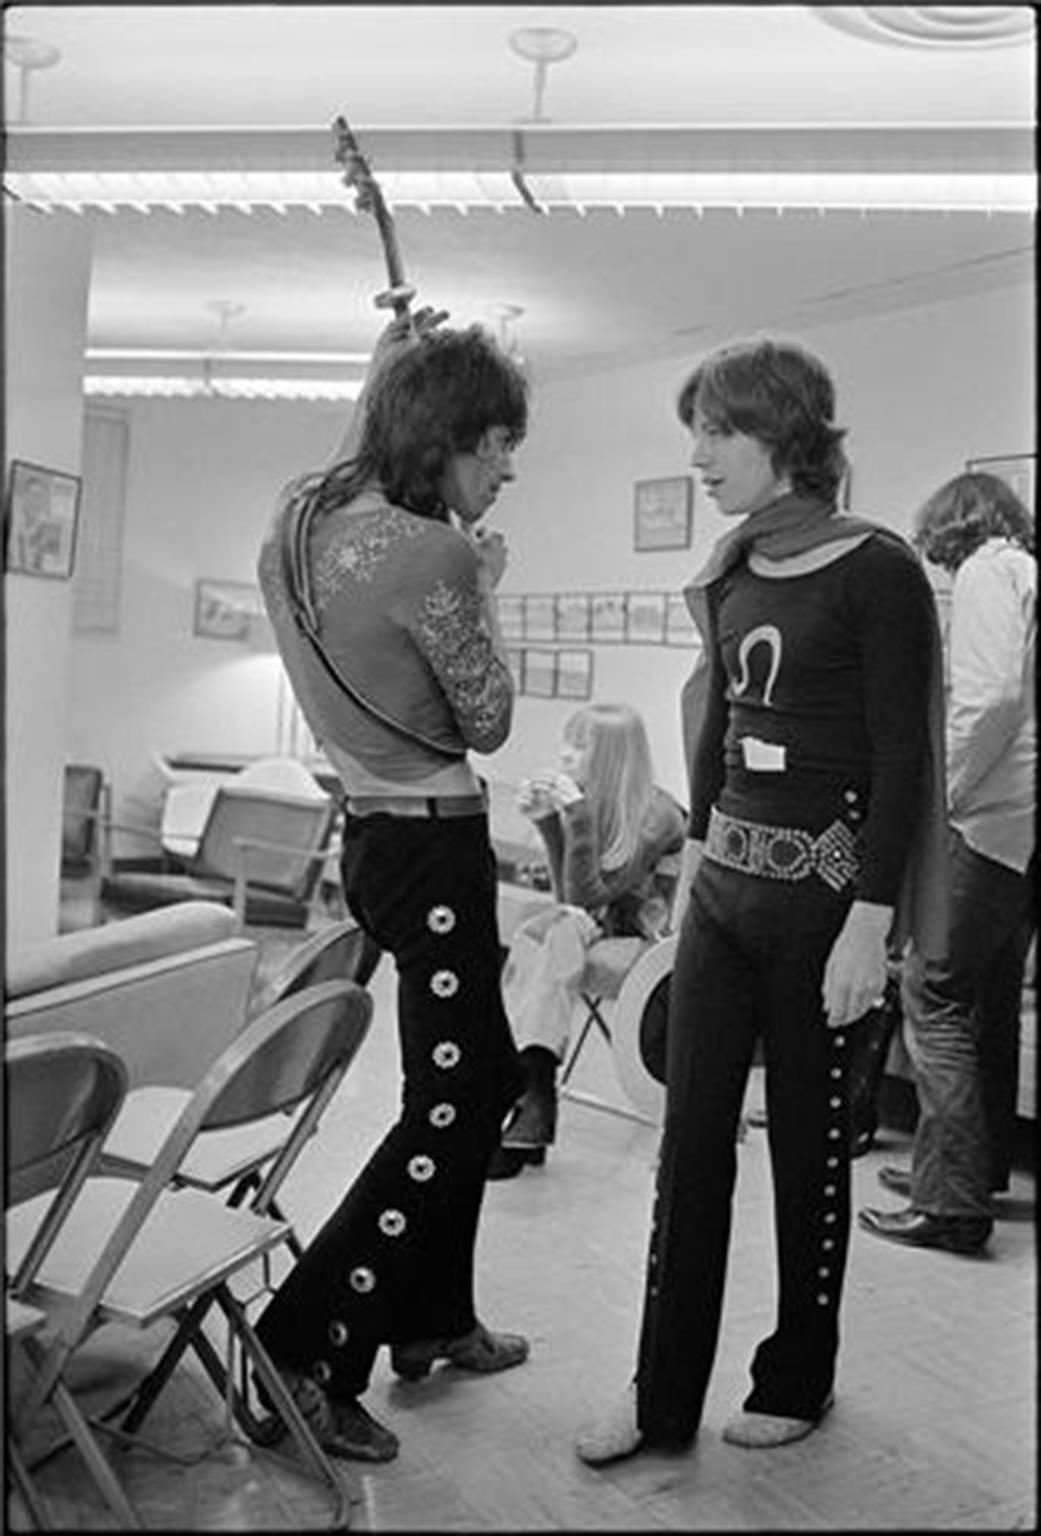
[258,485,513,790]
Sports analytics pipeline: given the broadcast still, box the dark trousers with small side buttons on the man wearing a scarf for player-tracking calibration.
[637,859,849,1447]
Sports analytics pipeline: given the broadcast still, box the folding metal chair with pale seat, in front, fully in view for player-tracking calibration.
[8,982,372,1525]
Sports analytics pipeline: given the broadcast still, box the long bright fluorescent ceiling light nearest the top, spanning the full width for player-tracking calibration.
[5,169,1036,215]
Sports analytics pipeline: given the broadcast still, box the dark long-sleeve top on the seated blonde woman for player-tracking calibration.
[536,786,685,938]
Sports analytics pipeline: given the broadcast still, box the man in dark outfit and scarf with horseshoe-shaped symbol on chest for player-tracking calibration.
[577,341,943,1465]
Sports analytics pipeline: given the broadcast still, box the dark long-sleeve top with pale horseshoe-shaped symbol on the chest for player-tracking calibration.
[689,535,935,905]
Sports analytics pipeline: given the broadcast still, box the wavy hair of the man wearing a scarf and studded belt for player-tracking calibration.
[676,341,848,502]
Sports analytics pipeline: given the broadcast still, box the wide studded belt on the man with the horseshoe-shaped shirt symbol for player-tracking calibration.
[705,808,860,891]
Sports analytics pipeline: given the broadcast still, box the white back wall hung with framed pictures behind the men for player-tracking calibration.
[71,276,1035,829]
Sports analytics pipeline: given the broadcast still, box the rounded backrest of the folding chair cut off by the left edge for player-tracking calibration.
[5,1031,126,1295]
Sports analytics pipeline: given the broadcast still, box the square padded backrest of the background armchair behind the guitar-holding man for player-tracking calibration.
[192,783,336,902]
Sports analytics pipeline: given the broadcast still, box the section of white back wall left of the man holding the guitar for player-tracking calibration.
[68,390,350,851]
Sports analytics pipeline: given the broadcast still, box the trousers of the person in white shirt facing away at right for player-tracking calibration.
[903,829,1032,1217]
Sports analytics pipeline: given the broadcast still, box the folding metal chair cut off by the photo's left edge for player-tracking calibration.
[5,1031,135,1527]
